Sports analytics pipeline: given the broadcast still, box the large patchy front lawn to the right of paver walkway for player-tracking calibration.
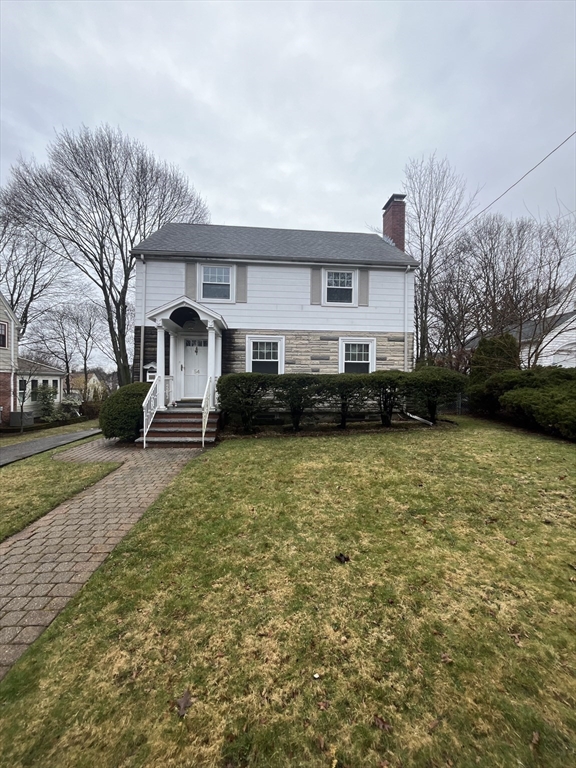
[0,419,576,768]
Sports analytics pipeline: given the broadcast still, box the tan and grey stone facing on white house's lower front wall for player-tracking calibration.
[222,329,413,373]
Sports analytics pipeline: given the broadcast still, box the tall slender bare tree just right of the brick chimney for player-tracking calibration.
[403,155,476,361]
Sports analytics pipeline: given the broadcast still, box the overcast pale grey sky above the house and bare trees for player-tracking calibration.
[1,0,576,231]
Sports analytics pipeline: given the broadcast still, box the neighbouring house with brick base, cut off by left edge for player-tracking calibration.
[0,293,66,424]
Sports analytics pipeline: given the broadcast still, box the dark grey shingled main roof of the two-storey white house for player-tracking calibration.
[132,224,417,267]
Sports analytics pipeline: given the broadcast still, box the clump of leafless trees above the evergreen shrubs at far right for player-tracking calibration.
[431,214,576,367]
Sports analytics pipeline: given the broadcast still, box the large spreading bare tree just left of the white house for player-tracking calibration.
[2,125,209,385]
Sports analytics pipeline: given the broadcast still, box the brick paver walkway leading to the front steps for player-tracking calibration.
[0,440,200,680]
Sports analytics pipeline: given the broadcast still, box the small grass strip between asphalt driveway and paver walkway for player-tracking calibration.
[0,438,119,541]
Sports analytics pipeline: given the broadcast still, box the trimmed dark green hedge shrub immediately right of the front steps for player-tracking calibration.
[217,373,278,432]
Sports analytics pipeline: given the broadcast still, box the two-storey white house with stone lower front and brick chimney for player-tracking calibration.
[133,195,417,409]
